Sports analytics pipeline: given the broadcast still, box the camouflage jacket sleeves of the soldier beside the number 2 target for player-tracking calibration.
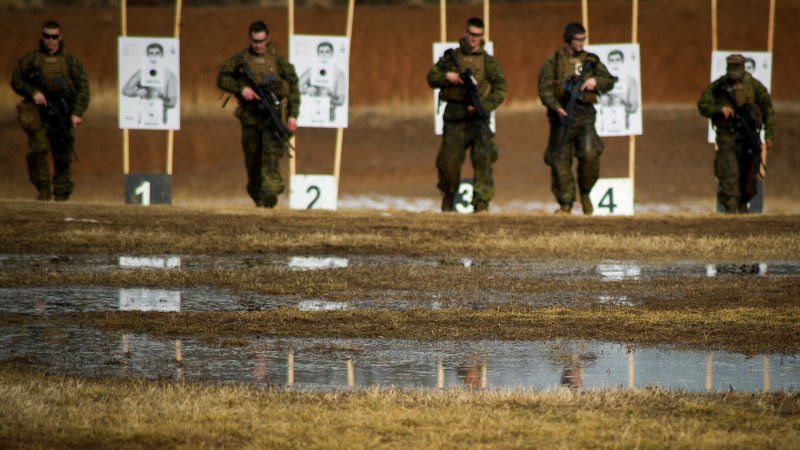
[217,45,300,121]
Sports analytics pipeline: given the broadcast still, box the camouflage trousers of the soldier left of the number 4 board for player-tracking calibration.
[544,121,603,205]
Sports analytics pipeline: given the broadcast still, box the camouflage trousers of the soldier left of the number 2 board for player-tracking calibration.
[242,123,286,206]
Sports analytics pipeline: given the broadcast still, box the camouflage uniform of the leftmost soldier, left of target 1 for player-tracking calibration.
[11,42,90,201]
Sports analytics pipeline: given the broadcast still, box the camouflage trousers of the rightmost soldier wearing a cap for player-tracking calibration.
[714,133,759,212]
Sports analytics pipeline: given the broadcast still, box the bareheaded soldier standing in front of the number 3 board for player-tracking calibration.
[428,17,506,212]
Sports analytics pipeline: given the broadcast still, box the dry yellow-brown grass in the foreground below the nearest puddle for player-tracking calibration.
[0,367,800,448]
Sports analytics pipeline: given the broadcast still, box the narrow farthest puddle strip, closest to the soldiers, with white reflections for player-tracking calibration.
[0,254,800,281]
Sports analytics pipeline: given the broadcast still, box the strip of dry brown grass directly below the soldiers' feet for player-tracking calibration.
[0,201,800,261]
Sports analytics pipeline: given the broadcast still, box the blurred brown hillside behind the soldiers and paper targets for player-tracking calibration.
[0,0,800,211]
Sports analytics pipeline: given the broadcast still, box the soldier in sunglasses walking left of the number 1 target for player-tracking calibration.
[11,21,90,201]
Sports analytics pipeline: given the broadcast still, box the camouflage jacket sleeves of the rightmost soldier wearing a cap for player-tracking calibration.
[697,73,775,139]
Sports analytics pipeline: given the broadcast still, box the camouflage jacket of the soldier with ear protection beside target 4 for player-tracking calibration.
[538,47,615,125]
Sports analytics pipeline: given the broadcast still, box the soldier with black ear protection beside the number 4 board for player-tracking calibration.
[539,23,614,215]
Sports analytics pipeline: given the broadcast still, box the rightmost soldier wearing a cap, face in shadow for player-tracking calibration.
[697,55,775,213]
